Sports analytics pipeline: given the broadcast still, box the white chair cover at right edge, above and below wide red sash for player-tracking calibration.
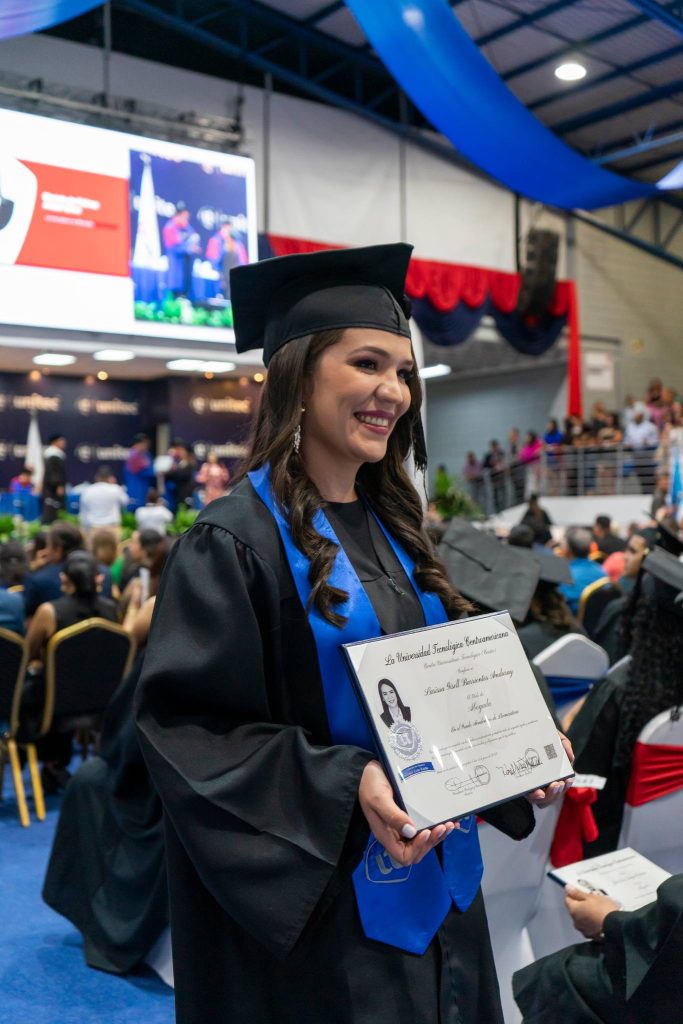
[618,711,683,874]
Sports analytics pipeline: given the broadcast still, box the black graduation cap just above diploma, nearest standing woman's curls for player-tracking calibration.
[438,519,540,623]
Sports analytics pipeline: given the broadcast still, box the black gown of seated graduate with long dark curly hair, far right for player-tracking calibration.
[567,658,631,857]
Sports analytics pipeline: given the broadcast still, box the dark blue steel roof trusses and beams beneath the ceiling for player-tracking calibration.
[68,0,683,268]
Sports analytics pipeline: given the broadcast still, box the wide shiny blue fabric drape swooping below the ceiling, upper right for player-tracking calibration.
[346,0,673,210]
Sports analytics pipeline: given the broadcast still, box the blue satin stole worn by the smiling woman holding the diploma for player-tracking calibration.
[248,467,483,954]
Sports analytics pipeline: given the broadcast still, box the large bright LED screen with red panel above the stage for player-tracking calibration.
[0,110,257,341]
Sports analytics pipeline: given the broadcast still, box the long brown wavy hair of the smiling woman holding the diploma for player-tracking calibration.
[239,331,470,627]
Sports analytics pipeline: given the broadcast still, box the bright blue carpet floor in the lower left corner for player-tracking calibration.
[0,768,174,1024]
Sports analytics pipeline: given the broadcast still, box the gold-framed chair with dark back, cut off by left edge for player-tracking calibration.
[0,629,45,827]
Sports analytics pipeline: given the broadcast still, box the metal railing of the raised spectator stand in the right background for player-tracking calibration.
[466,444,665,515]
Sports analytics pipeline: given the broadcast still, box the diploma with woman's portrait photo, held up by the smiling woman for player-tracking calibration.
[342,611,573,828]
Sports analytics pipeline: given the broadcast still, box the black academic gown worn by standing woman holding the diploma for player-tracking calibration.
[137,481,533,1024]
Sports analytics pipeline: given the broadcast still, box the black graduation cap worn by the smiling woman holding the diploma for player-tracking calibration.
[230,242,413,367]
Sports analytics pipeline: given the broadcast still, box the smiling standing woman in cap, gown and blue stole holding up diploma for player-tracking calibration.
[137,245,562,1024]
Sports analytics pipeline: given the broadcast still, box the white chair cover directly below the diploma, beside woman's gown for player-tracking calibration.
[479,806,559,1024]
